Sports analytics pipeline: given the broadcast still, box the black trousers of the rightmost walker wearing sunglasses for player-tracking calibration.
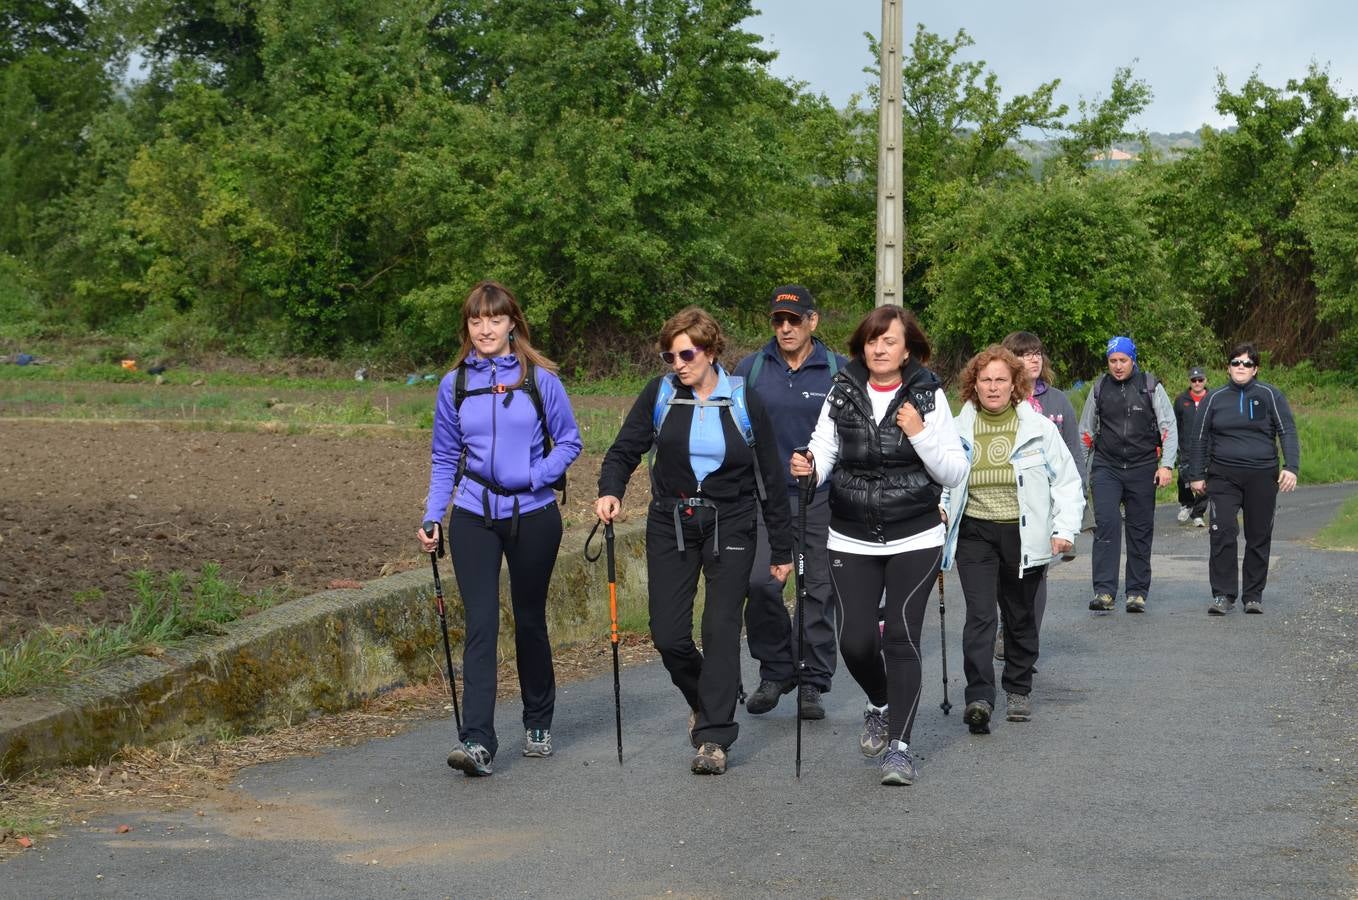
[1207,466,1278,603]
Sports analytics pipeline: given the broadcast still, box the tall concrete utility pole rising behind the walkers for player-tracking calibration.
[877,0,906,307]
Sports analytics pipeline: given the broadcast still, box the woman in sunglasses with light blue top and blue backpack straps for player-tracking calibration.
[595,307,792,775]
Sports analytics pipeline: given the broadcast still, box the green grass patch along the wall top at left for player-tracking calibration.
[0,562,274,696]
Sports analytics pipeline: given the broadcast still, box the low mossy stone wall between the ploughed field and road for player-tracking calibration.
[0,521,645,776]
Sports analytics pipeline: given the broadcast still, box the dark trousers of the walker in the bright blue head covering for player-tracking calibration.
[1091,460,1158,597]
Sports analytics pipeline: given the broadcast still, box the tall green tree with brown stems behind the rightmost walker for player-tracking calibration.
[1153,65,1358,362]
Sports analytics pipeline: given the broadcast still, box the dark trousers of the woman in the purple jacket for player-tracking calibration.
[448,504,561,756]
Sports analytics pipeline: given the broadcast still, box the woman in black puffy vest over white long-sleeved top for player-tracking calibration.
[790,307,967,785]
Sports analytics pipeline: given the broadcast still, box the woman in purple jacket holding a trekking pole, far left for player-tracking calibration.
[417,281,580,775]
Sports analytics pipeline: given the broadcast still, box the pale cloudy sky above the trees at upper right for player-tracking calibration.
[744,0,1358,132]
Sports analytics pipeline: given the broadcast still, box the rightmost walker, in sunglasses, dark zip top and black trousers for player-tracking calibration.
[1188,343,1301,616]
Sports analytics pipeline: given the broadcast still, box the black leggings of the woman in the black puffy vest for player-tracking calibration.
[830,547,942,744]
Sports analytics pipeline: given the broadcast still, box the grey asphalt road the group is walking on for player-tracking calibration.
[0,486,1358,899]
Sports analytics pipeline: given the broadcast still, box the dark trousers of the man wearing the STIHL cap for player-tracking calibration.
[746,490,835,694]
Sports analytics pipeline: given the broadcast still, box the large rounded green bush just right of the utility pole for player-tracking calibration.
[928,167,1207,377]
